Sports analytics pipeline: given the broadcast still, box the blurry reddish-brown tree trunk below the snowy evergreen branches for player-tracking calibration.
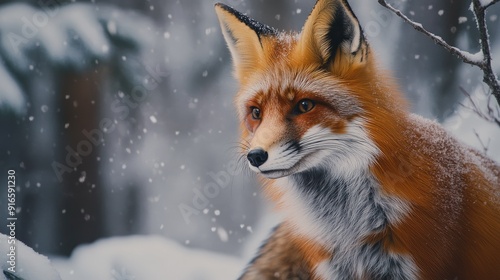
[60,71,104,255]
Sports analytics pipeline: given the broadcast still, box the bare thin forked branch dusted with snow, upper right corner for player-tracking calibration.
[378,0,500,106]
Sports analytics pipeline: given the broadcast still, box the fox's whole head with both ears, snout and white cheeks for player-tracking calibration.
[216,0,406,178]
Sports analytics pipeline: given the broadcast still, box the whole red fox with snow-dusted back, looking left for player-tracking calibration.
[215,0,500,280]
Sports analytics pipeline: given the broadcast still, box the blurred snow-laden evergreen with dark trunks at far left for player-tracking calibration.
[0,0,151,253]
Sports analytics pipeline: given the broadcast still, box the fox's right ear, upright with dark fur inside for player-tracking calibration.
[298,0,368,75]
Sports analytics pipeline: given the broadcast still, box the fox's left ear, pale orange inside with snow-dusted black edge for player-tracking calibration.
[215,3,277,81]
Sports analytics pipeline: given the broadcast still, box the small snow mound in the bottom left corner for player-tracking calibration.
[0,233,61,280]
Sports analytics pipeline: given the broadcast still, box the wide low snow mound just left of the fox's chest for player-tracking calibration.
[51,236,245,280]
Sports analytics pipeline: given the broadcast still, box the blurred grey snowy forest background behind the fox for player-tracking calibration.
[0,0,500,260]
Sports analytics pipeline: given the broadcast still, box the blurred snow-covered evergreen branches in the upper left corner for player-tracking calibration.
[0,3,154,112]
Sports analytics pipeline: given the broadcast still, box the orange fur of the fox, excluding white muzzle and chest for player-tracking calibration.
[217,0,500,279]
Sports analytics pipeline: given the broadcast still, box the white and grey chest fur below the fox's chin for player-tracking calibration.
[277,168,417,279]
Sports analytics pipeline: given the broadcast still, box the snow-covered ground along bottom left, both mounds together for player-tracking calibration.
[0,235,244,280]
